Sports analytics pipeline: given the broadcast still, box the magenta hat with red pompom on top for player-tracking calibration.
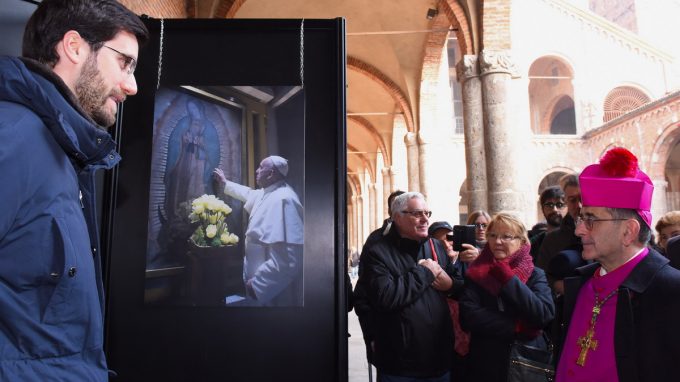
[579,147,654,227]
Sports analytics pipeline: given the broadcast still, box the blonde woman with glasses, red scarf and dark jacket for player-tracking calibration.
[460,213,555,382]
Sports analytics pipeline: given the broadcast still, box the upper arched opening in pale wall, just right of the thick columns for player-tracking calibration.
[529,56,576,134]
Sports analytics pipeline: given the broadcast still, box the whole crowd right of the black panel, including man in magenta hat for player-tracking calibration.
[353,148,680,382]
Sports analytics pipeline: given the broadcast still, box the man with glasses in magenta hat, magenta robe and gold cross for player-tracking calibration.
[557,148,680,381]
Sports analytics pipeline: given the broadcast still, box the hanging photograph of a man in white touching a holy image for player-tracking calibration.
[144,86,304,307]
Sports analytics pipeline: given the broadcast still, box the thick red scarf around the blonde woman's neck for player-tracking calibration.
[466,243,534,296]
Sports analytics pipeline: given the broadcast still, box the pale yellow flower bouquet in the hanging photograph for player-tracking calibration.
[189,195,238,247]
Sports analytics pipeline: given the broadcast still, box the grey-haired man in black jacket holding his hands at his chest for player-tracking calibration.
[358,192,454,382]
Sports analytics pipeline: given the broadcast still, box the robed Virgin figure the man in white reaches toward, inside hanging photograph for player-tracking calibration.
[165,99,220,219]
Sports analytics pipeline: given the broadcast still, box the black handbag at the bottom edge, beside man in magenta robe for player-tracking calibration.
[508,333,555,382]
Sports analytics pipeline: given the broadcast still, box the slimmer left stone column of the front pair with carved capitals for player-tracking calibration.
[456,55,488,213]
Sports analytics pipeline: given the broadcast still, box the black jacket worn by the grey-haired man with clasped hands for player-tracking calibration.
[357,226,458,377]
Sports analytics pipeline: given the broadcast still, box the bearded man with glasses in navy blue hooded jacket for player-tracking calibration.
[0,0,148,381]
